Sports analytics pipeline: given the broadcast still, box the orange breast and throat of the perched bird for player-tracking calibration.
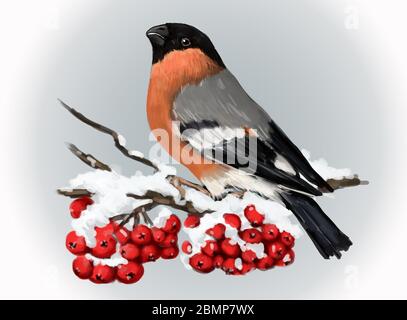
[147,49,222,179]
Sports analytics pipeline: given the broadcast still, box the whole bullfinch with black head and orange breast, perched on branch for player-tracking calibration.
[146,23,352,259]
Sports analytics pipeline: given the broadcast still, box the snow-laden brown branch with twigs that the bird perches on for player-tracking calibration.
[57,101,367,233]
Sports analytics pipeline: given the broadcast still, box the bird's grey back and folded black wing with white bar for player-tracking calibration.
[172,69,330,195]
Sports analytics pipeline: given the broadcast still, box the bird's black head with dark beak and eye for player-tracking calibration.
[146,23,225,68]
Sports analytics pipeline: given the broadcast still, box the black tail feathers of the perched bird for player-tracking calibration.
[281,192,352,259]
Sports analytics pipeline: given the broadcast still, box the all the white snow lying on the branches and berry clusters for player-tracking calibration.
[65,148,351,269]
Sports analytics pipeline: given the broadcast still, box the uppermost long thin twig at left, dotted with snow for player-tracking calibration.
[59,100,158,170]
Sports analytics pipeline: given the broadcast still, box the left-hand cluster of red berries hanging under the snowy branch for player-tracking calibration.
[66,197,181,284]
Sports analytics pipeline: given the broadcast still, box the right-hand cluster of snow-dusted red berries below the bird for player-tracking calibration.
[182,205,295,275]
